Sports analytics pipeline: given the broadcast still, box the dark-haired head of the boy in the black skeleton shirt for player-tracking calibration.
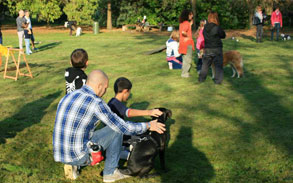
[70,48,88,68]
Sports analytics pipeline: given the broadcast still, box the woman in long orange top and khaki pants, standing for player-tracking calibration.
[179,10,194,78]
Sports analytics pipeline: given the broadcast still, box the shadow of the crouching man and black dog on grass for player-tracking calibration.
[161,126,215,183]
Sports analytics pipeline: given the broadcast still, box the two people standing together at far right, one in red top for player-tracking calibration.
[252,6,283,43]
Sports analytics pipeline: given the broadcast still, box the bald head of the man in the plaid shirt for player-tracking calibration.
[86,70,109,97]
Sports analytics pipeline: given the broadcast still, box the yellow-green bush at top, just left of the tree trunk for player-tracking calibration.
[63,0,99,25]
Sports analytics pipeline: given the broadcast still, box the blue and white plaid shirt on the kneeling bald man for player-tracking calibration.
[53,85,147,163]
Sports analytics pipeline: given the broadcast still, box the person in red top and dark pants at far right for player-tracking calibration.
[271,7,283,41]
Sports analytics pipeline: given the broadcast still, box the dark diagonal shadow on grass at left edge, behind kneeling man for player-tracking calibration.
[0,91,61,144]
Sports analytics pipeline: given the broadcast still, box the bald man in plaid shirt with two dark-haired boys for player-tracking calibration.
[53,49,165,182]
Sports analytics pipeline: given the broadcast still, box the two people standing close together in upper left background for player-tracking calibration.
[16,10,37,55]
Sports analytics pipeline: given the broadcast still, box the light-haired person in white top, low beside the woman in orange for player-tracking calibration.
[166,30,182,69]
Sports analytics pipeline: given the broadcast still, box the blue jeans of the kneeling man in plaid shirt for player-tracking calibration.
[66,126,123,175]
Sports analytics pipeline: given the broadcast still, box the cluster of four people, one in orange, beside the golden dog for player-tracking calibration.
[166,10,226,84]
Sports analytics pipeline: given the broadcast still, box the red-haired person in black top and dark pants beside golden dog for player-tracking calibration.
[198,12,226,84]
